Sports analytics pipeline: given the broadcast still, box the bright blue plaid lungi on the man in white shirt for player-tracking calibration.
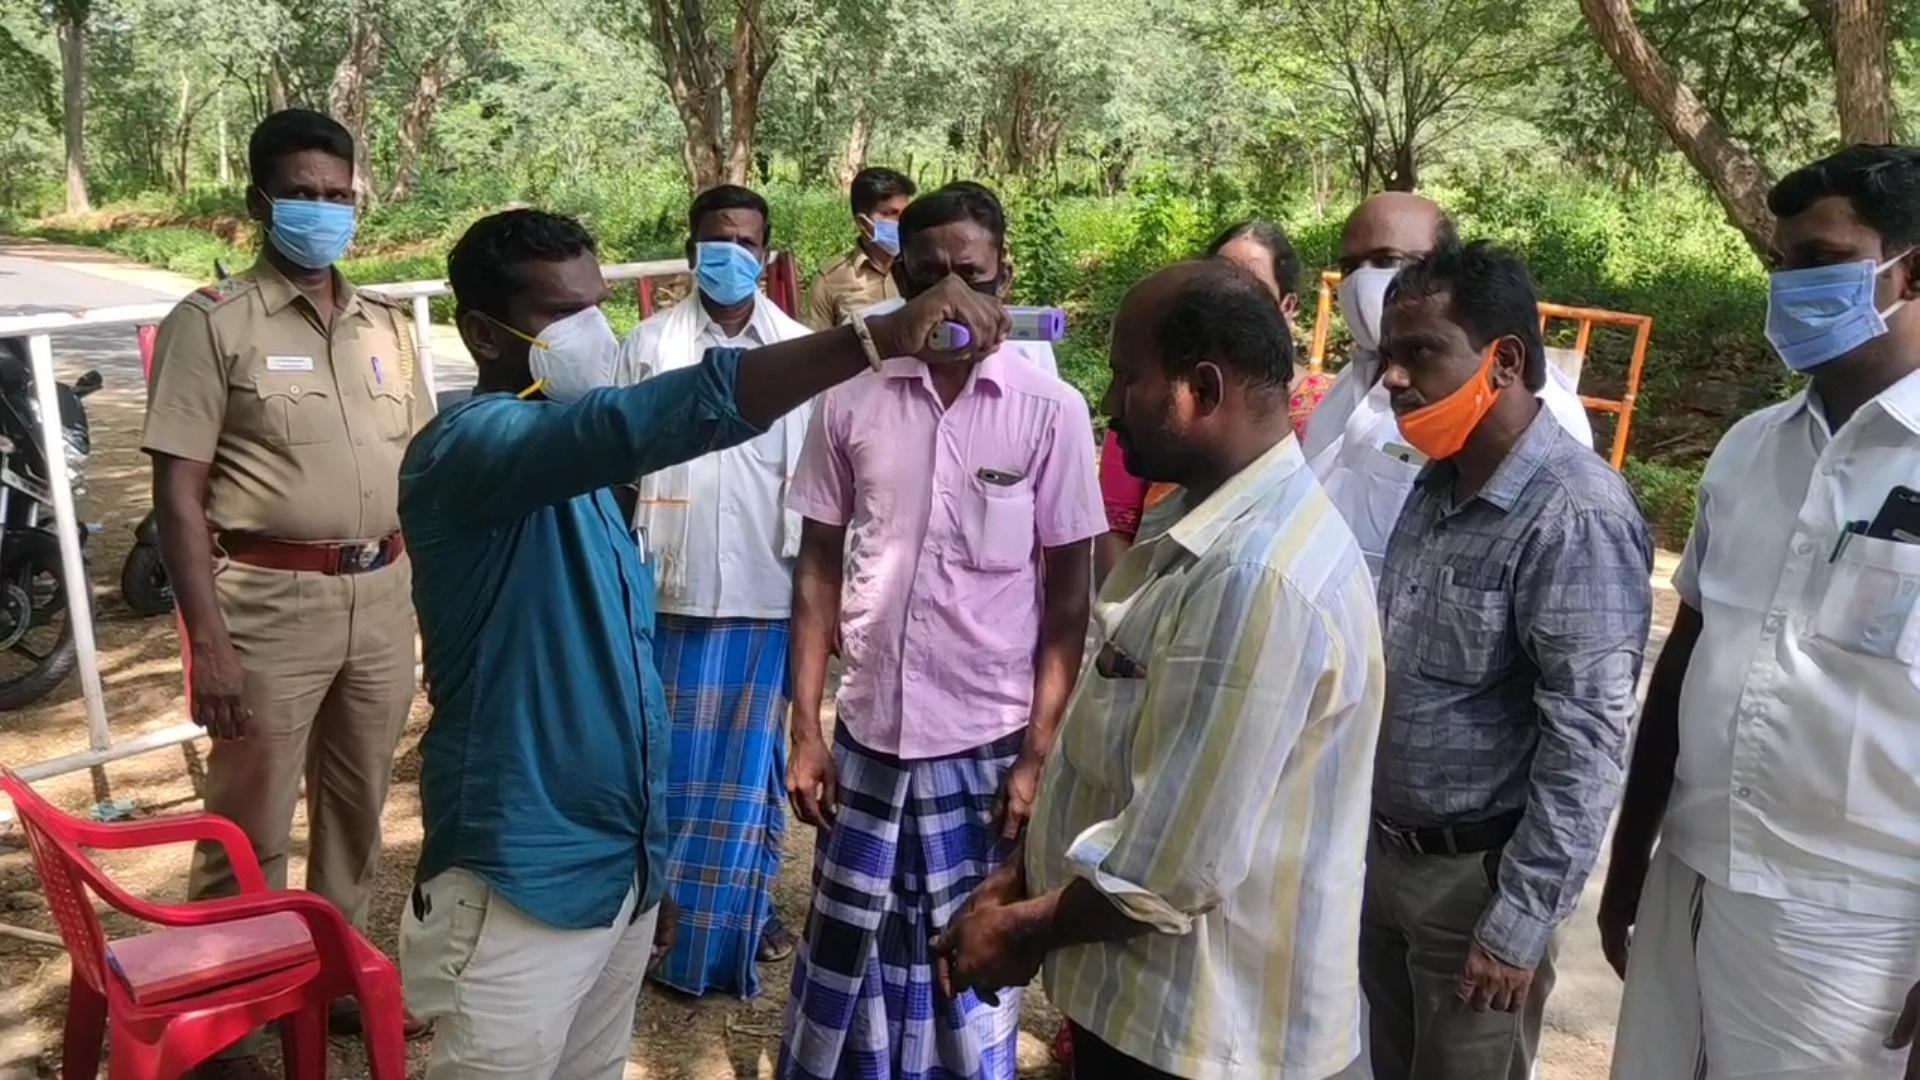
[653,613,787,997]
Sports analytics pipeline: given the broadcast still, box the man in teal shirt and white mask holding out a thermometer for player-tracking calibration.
[399,209,1006,1080]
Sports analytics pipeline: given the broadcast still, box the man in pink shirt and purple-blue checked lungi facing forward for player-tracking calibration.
[778,183,1106,1080]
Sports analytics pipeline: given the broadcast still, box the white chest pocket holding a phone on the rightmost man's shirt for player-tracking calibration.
[1812,536,1920,667]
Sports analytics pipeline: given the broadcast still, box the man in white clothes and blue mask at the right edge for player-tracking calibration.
[1599,146,1920,1080]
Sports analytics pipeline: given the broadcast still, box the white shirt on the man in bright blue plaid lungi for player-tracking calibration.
[618,296,812,619]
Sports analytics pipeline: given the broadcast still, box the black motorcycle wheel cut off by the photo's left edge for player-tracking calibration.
[0,528,75,709]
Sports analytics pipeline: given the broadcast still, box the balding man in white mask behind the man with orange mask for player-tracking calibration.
[1304,192,1594,578]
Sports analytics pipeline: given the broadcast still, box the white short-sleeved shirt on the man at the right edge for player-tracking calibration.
[1665,373,1920,919]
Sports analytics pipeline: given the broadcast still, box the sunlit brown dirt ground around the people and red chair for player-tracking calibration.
[0,244,1672,1080]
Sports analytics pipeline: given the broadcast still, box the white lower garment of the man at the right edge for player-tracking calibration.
[1613,849,1920,1080]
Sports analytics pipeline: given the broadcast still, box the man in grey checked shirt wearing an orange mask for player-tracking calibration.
[1361,244,1653,1080]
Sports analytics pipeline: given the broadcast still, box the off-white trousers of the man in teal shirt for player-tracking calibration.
[399,869,659,1080]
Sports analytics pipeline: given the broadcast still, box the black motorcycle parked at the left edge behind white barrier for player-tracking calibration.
[0,338,100,709]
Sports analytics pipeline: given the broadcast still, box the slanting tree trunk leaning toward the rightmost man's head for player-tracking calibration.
[1580,0,1774,259]
